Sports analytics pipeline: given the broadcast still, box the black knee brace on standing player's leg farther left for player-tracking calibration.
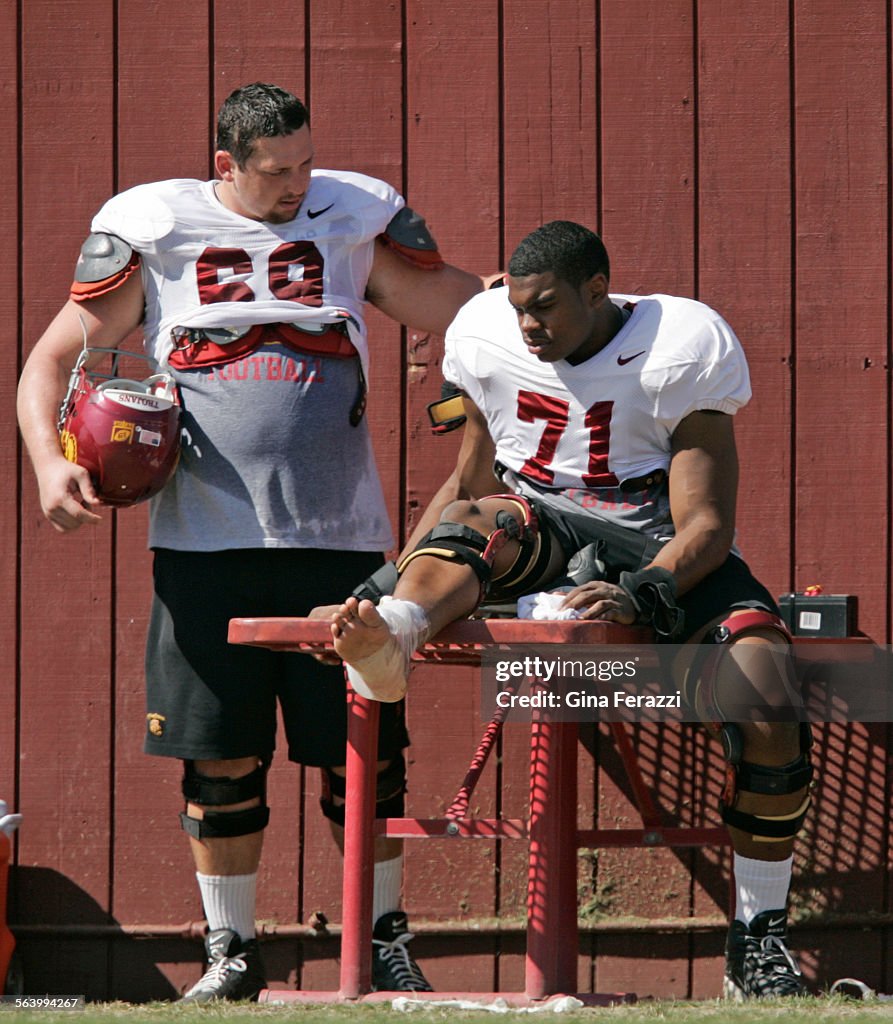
[180,761,269,840]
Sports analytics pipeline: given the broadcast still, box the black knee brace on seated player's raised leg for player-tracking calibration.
[397,495,549,600]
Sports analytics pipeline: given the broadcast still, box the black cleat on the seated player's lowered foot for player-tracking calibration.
[723,910,806,1001]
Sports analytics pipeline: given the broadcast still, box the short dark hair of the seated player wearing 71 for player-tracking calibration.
[508,220,610,288]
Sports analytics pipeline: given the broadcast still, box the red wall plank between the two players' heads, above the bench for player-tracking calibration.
[403,0,502,534]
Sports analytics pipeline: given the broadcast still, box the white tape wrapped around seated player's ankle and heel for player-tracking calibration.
[347,597,429,703]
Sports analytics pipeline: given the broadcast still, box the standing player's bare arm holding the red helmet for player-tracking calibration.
[16,273,143,532]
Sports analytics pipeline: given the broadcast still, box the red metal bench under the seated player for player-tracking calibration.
[229,618,741,1005]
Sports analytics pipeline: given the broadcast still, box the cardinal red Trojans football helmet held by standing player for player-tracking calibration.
[58,349,180,507]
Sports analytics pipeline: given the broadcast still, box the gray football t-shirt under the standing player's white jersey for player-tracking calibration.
[150,344,393,551]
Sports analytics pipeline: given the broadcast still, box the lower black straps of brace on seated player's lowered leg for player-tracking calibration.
[720,722,813,843]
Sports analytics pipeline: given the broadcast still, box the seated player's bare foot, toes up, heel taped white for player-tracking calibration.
[332,597,415,703]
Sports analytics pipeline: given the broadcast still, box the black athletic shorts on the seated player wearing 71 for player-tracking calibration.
[528,497,779,643]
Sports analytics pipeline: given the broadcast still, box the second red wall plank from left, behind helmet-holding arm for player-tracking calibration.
[18,0,115,998]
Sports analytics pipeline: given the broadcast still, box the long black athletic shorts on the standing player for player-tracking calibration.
[144,548,409,767]
